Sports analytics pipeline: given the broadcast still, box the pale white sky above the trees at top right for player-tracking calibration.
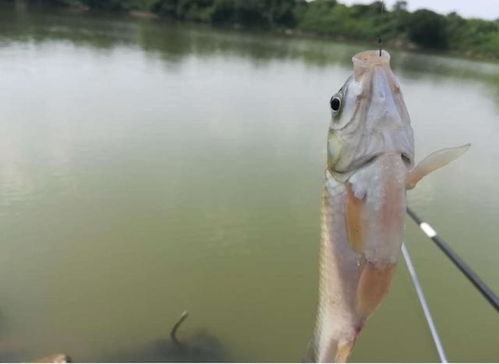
[339,0,499,20]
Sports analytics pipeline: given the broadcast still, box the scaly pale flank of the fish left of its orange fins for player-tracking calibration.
[310,172,361,362]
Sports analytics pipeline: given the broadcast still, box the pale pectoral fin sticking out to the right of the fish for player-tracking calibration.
[406,144,471,190]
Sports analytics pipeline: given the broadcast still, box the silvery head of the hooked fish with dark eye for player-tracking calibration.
[328,50,414,182]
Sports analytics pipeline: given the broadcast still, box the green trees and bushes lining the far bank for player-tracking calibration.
[20,0,499,58]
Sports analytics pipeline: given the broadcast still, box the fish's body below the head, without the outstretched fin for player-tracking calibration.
[309,155,406,362]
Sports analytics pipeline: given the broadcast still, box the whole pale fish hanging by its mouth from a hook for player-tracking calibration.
[305,50,470,362]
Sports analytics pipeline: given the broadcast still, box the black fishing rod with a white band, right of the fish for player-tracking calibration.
[407,207,499,312]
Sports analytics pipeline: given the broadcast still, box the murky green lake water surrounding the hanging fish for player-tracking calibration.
[0,5,499,361]
